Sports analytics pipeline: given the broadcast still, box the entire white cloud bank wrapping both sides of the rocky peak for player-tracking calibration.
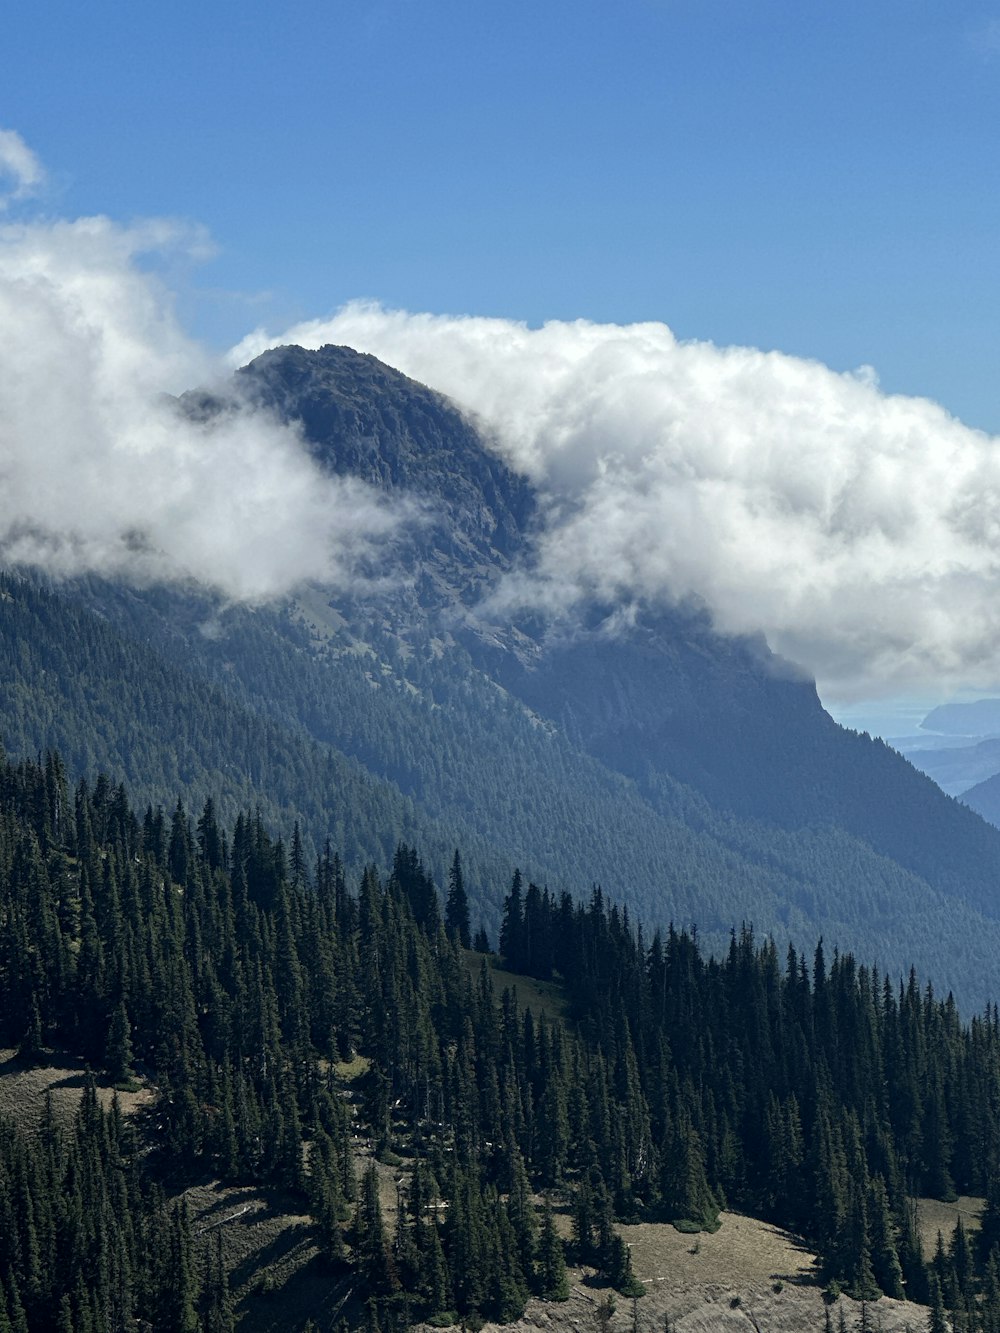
[7,131,1000,701]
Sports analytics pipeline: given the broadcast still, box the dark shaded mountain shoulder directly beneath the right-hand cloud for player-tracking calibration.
[501,611,1000,916]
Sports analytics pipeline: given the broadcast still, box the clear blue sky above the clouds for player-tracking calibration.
[7,0,1000,431]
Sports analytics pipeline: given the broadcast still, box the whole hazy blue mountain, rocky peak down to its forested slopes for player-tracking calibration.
[0,347,1000,1006]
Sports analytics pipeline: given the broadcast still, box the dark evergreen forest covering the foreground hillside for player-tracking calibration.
[0,752,1000,1333]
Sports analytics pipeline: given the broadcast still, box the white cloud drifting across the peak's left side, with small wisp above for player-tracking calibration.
[0,203,396,600]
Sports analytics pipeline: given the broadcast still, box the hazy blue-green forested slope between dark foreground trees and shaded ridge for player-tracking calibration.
[0,567,1000,1006]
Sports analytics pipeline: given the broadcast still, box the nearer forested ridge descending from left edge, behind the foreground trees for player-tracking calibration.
[0,576,482,874]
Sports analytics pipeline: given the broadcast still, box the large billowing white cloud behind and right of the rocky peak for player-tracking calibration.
[232,304,1000,701]
